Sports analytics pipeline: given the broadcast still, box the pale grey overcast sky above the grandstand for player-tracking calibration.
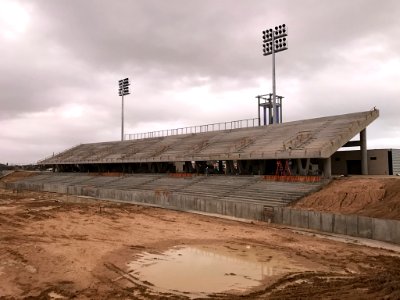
[0,0,400,163]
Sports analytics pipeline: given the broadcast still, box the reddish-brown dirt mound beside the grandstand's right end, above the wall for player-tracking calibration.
[292,176,400,220]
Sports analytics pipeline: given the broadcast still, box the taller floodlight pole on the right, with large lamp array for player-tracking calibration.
[263,24,287,124]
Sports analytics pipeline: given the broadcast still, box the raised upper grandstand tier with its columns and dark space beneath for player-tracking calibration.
[38,109,379,177]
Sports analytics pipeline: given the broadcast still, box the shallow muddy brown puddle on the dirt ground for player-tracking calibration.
[128,246,303,294]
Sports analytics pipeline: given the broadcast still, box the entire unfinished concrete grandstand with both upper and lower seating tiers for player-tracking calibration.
[7,109,379,220]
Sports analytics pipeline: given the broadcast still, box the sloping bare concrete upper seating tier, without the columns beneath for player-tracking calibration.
[38,109,379,165]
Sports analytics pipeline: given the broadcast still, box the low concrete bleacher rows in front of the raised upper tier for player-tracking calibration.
[11,173,324,206]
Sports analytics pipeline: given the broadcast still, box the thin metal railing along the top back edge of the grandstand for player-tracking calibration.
[125,118,259,140]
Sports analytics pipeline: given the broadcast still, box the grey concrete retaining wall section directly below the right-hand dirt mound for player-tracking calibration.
[273,207,400,244]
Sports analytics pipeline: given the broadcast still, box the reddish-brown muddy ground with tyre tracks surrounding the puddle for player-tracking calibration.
[0,189,400,299]
